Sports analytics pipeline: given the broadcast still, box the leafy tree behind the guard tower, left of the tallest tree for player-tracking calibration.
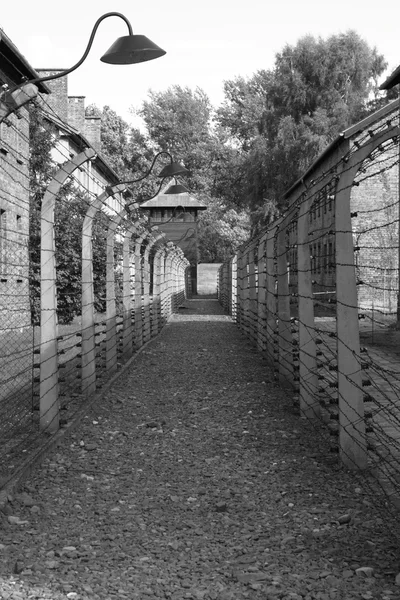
[138,85,249,262]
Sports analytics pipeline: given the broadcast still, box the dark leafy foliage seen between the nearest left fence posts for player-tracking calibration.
[29,108,106,323]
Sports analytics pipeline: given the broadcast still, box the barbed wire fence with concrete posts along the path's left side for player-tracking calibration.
[0,101,188,487]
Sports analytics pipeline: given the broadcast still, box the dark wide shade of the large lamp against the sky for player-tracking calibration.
[100,35,166,65]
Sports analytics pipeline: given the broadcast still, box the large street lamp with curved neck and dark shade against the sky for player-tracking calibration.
[0,12,166,121]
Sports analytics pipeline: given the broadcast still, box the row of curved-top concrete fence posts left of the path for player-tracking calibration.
[35,149,189,433]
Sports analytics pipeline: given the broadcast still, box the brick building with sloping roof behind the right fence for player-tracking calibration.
[285,100,399,312]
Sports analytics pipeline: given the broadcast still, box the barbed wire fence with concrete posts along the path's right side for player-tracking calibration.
[218,102,400,528]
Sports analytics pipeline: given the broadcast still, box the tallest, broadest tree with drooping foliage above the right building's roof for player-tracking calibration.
[217,31,386,228]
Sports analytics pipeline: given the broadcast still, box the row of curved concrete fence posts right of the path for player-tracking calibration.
[218,122,398,469]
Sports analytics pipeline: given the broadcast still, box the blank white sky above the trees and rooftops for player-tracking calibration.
[0,0,400,124]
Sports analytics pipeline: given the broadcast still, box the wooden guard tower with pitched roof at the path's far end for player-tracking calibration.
[140,186,207,294]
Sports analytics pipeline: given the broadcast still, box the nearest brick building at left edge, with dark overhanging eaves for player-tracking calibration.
[0,31,48,330]
